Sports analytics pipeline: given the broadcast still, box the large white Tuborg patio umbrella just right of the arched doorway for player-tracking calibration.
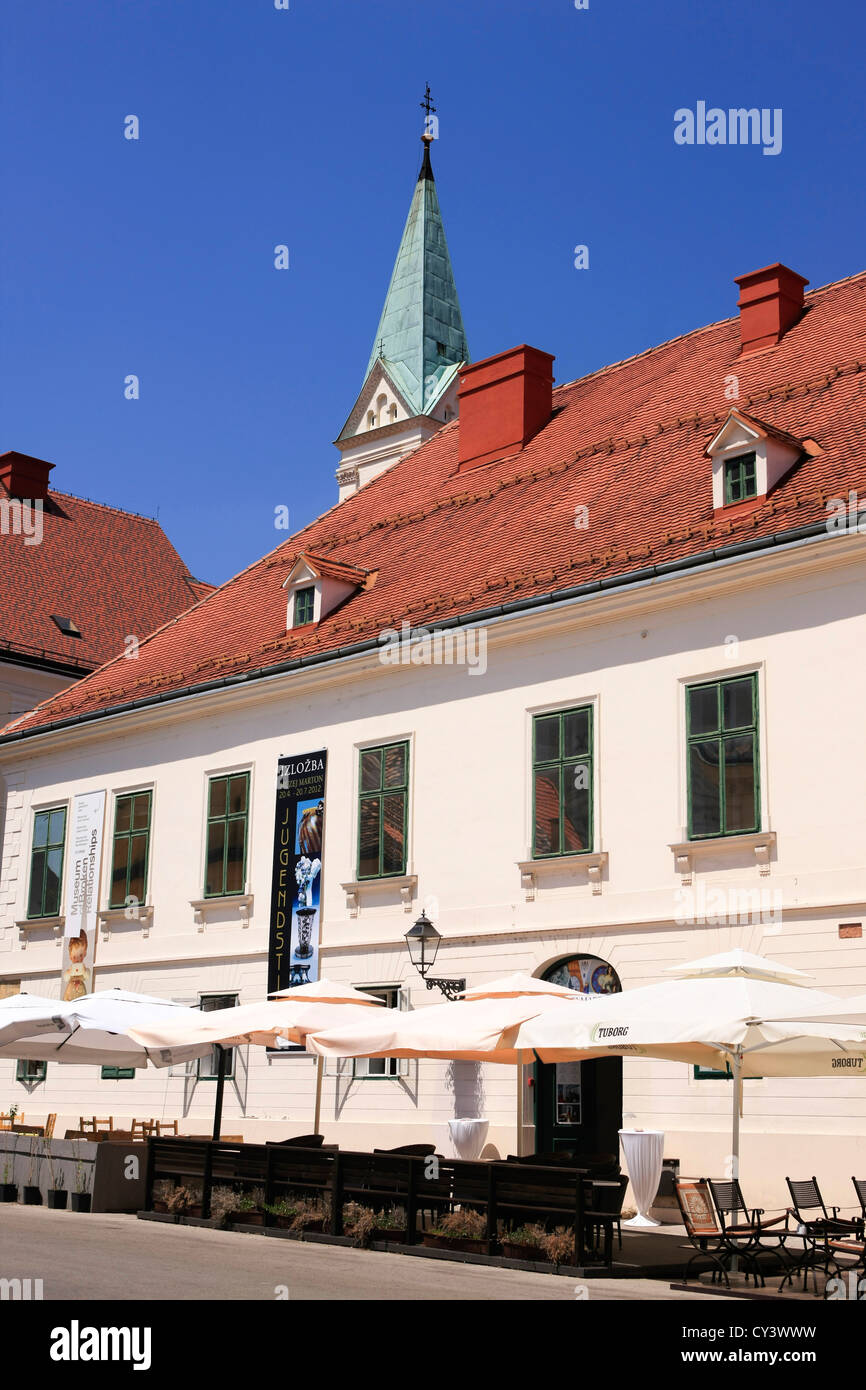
[516,952,866,1176]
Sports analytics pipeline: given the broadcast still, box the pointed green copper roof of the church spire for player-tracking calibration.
[364,136,468,416]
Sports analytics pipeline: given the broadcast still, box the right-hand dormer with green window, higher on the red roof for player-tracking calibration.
[705,410,805,512]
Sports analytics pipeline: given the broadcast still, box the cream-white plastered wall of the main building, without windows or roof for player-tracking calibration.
[0,538,866,1205]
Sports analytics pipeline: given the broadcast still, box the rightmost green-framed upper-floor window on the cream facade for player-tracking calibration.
[685,671,760,840]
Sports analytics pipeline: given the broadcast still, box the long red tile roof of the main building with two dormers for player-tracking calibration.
[7,271,866,734]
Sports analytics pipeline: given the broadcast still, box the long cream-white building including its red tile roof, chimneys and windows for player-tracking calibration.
[0,143,866,1208]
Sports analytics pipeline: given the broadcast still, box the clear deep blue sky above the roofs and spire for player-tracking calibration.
[0,0,866,581]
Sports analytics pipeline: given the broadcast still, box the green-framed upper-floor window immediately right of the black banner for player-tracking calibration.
[357,739,409,878]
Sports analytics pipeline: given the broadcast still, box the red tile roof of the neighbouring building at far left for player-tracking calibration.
[0,484,213,673]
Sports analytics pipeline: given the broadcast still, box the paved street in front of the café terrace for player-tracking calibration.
[0,1205,733,1302]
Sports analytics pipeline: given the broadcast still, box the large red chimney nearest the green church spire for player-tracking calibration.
[457,343,553,470]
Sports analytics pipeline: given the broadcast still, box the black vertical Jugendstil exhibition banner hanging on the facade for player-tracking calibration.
[268,748,328,994]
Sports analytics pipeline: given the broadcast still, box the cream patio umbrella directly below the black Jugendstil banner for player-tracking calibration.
[128,980,382,1138]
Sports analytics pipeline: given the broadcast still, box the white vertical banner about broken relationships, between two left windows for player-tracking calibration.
[60,791,106,1004]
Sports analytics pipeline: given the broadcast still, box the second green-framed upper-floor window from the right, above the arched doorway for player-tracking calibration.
[532,705,595,859]
